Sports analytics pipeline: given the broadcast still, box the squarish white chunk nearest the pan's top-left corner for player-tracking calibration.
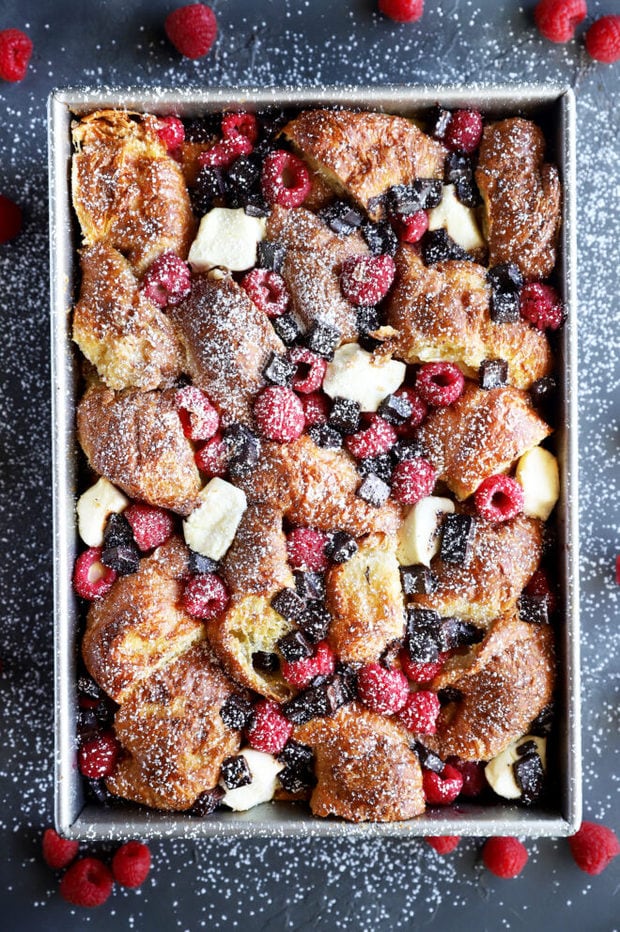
[188,207,267,272]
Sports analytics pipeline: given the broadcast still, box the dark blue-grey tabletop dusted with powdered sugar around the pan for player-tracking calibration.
[0,0,620,932]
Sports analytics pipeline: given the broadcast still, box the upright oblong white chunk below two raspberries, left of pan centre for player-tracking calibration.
[183,476,247,560]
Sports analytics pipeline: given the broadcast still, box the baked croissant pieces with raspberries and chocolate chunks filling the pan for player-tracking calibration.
[72,102,564,822]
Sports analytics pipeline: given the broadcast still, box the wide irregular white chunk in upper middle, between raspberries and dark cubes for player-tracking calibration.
[323,343,406,411]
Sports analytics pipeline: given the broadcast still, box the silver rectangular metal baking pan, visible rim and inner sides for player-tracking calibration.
[49,86,581,839]
